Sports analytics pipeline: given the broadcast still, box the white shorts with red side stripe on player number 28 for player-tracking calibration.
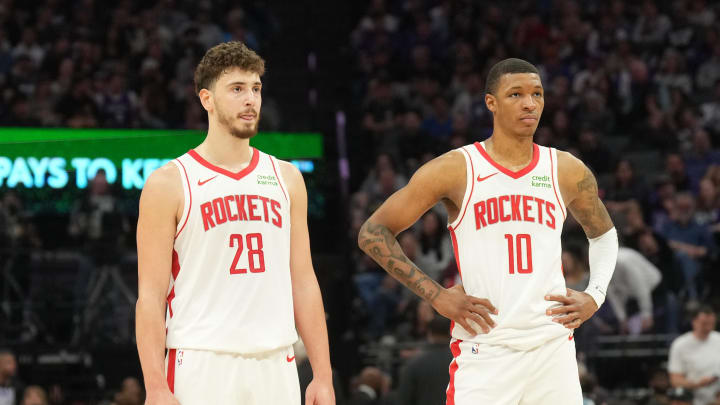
[165,346,300,405]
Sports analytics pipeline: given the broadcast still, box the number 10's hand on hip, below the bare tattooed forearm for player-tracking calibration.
[432,284,498,335]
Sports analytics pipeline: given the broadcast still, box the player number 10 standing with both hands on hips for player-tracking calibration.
[358,59,618,405]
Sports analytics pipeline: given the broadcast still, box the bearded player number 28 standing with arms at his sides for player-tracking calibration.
[136,42,335,405]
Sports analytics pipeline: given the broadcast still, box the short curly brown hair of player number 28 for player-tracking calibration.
[194,41,265,94]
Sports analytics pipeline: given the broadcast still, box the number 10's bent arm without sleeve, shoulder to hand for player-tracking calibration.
[358,151,496,333]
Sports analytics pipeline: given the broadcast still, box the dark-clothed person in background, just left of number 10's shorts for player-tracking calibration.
[397,316,452,405]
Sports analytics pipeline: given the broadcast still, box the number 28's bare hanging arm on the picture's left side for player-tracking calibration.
[135,163,183,405]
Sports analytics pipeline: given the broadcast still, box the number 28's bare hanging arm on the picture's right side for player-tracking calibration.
[280,162,335,405]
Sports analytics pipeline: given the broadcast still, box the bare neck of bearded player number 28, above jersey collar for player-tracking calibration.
[195,128,252,170]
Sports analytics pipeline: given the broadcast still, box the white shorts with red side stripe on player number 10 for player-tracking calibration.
[447,334,583,405]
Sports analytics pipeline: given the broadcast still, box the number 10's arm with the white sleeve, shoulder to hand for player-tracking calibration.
[545,151,618,329]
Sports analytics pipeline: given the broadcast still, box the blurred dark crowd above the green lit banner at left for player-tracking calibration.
[0,0,277,130]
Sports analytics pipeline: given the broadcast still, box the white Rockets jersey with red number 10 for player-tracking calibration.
[448,143,570,350]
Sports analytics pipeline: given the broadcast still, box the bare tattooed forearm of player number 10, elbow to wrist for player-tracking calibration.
[358,220,442,303]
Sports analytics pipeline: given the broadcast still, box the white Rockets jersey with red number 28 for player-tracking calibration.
[166,148,297,353]
